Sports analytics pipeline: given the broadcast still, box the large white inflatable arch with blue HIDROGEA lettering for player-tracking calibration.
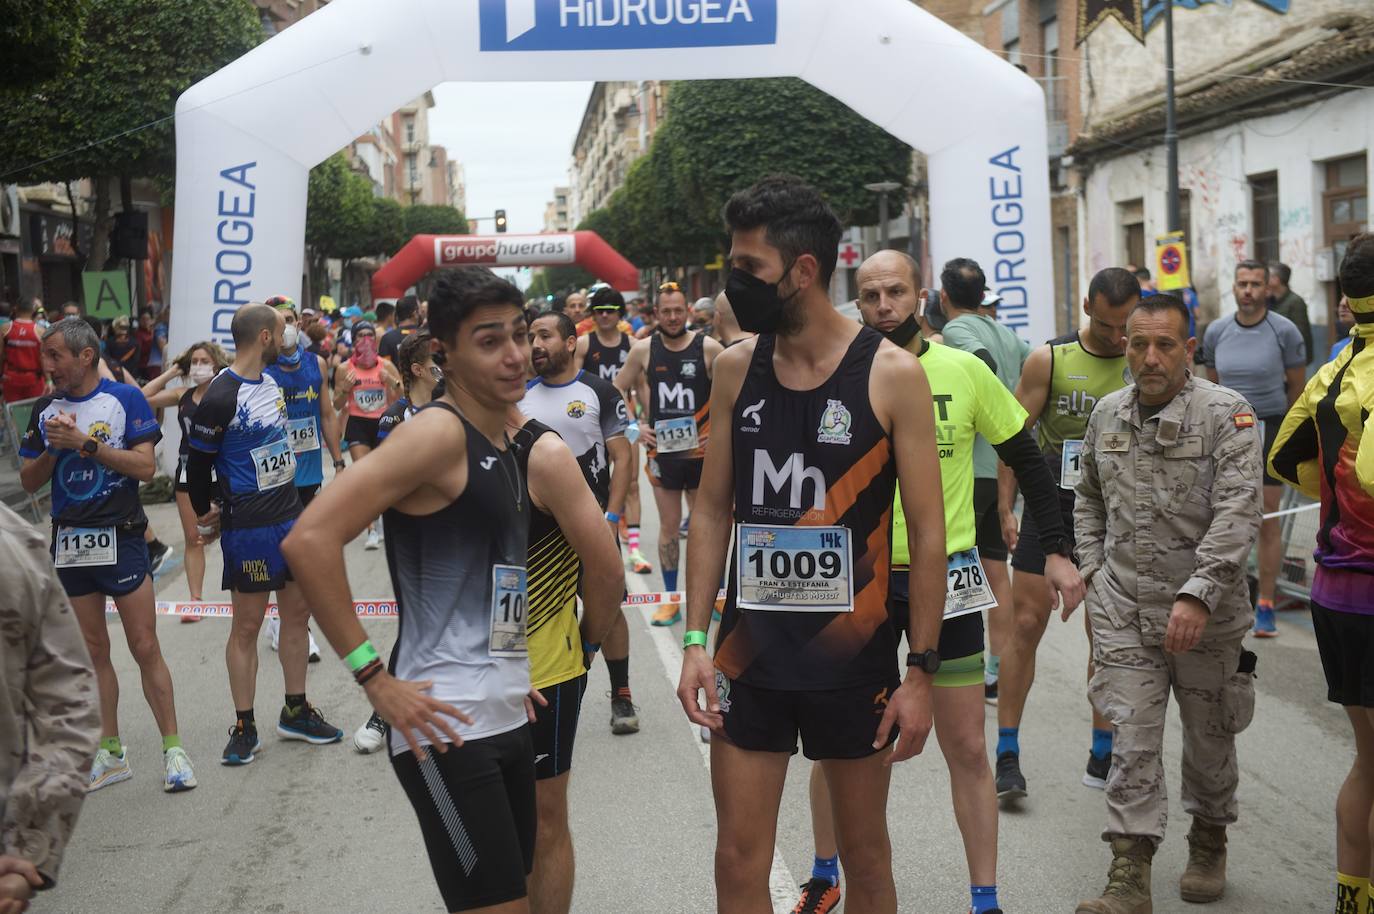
[170,0,1054,362]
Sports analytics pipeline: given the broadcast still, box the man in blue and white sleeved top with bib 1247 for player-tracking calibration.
[187,302,344,766]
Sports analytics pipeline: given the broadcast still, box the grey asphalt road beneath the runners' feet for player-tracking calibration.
[45,464,1353,914]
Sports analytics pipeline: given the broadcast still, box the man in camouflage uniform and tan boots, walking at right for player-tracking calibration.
[1073,294,1261,914]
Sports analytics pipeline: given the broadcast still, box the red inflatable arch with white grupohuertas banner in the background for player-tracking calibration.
[372,232,639,301]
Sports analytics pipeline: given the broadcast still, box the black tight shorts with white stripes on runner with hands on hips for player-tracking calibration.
[392,726,536,911]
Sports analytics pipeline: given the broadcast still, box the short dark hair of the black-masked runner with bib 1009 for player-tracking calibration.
[724,175,844,285]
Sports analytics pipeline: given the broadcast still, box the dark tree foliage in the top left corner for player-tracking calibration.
[0,0,91,89]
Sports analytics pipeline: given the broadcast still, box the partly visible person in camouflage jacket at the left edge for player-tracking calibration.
[0,504,100,911]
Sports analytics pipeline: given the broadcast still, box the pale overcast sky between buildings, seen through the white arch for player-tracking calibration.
[429,82,592,235]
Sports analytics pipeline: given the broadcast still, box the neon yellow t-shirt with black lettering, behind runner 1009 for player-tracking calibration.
[892,337,1026,568]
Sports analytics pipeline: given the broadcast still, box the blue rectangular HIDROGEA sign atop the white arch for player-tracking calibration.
[478,0,779,51]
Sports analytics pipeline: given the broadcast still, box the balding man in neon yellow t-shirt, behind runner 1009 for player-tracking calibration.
[808,250,1083,913]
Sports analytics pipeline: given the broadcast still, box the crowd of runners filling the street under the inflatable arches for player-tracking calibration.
[8,177,1374,914]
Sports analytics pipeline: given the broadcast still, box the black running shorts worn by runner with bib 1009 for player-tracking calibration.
[716,669,901,760]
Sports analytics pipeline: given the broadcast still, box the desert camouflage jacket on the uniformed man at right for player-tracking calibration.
[1073,375,1263,646]
